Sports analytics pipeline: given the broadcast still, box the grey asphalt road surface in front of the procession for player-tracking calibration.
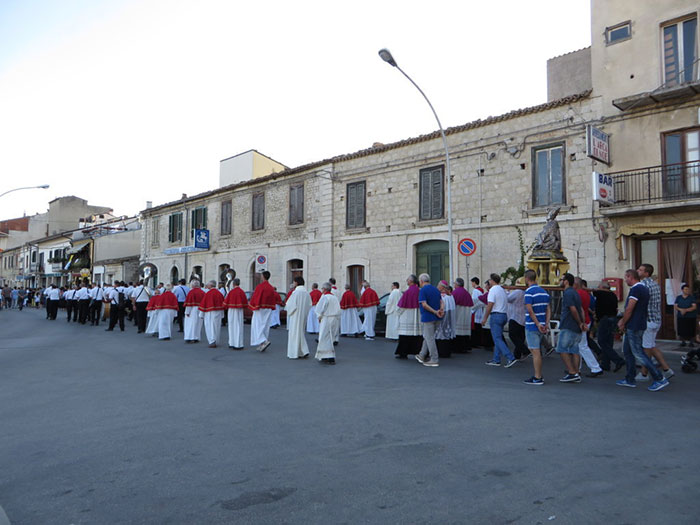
[0,310,700,524]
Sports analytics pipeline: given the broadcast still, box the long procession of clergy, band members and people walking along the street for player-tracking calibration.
[8,264,700,391]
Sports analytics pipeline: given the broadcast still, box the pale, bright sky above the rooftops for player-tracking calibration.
[0,0,591,219]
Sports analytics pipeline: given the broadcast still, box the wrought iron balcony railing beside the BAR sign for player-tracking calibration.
[606,160,700,206]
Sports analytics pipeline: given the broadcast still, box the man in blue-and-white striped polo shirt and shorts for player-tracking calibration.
[523,270,552,385]
